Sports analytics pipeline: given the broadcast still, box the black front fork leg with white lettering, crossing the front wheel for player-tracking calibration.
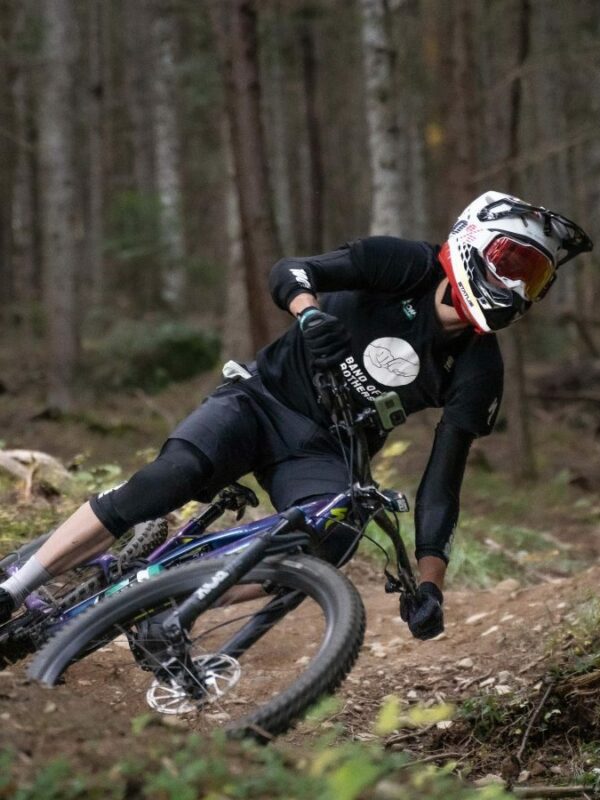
[162,508,307,644]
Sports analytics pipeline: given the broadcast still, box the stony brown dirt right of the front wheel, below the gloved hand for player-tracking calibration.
[291,567,600,739]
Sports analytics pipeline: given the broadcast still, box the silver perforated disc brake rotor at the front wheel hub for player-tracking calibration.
[146,653,241,714]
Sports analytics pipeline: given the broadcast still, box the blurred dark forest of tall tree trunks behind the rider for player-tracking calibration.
[0,0,600,474]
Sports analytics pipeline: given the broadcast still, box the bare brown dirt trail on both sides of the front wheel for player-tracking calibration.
[0,563,600,767]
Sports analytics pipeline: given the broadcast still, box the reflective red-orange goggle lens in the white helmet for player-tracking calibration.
[484,236,555,300]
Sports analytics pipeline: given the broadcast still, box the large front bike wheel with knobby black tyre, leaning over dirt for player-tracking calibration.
[29,555,365,740]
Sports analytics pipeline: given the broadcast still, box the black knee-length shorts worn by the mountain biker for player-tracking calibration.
[169,367,350,511]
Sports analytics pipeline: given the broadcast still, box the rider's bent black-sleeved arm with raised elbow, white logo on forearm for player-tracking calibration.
[269,236,443,314]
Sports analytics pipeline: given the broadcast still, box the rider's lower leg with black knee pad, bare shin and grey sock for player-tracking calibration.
[0,439,212,621]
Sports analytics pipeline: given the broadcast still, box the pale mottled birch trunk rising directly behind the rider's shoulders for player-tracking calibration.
[360,0,407,236]
